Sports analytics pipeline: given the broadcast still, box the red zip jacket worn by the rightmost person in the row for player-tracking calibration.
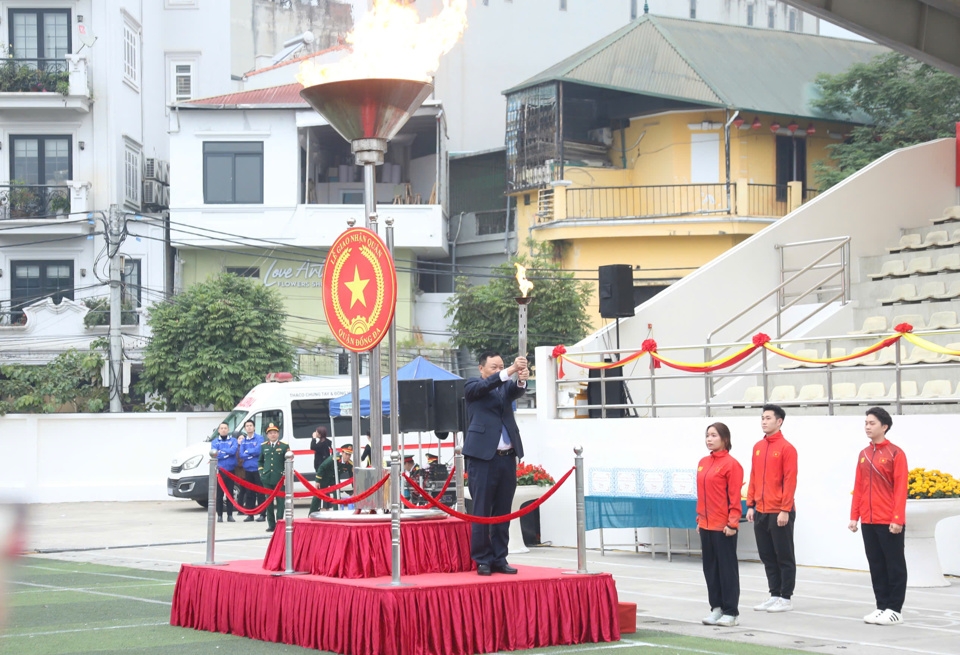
[850,440,910,525]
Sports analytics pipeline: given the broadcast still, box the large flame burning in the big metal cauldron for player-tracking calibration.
[297,0,467,87]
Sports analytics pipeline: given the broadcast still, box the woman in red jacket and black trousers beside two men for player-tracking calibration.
[697,423,743,627]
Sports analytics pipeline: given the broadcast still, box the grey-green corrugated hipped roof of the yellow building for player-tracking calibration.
[505,15,888,118]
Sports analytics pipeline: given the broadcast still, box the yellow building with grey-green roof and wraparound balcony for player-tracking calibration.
[505,15,886,326]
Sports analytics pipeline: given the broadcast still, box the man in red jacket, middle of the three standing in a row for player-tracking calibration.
[747,405,797,612]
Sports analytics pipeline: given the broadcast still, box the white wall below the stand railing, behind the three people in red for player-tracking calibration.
[517,411,960,575]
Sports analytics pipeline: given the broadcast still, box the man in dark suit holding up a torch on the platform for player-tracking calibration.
[463,352,530,575]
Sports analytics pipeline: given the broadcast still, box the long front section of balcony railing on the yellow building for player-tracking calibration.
[566,184,736,219]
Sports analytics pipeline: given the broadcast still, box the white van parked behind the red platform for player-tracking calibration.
[167,374,367,507]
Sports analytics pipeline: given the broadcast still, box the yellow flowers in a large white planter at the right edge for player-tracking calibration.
[904,468,960,587]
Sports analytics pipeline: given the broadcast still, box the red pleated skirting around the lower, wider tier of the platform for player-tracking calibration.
[170,561,620,655]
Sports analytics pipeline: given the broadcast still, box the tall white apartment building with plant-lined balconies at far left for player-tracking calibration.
[0,0,231,362]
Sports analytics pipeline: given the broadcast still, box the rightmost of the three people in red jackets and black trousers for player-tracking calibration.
[849,407,910,625]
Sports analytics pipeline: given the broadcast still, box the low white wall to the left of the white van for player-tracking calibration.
[0,412,224,503]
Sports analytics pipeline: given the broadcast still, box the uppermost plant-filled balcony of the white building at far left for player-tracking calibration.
[0,55,91,113]
